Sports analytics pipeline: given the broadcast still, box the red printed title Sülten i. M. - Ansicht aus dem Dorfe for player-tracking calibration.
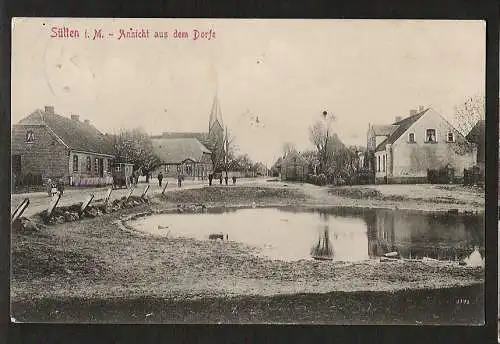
[50,26,215,41]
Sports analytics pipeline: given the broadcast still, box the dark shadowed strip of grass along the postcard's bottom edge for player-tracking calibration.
[13,286,484,325]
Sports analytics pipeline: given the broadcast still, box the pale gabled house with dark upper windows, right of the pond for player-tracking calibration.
[367,107,477,183]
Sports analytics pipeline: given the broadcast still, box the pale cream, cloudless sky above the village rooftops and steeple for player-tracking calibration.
[12,18,486,166]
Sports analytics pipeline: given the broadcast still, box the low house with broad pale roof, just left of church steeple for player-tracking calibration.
[152,138,213,180]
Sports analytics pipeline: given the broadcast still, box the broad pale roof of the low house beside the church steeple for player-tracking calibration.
[152,138,211,164]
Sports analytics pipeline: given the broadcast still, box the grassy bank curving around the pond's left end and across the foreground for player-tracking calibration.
[11,186,484,323]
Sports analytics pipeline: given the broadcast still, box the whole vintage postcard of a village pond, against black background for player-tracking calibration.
[10,18,486,325]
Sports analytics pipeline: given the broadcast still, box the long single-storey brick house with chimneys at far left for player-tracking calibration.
[11,106,113,186]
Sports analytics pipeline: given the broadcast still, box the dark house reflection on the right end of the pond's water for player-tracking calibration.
[363,210,484,260]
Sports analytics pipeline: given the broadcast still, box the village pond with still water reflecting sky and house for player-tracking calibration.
[130,207,484,264]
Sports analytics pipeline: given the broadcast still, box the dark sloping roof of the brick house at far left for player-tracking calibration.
[17,110,113,155]
